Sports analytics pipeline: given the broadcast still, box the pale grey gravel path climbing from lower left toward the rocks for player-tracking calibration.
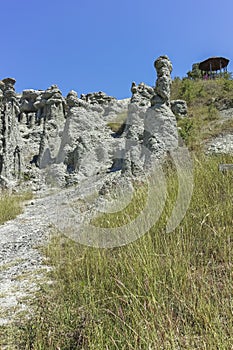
[0,178,104,326]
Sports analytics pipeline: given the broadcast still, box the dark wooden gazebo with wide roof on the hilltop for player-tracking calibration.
[199,57,229,78]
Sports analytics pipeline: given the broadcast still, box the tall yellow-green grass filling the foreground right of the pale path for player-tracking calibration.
[13,156,233,350]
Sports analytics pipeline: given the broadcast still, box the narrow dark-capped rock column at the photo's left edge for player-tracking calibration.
[0,78,23,185]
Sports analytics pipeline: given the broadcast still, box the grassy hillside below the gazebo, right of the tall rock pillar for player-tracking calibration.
[172,78,233,153]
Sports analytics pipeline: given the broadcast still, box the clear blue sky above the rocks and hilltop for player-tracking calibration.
[0,0,233,98]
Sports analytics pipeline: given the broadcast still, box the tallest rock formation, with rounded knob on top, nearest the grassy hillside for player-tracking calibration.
[123,56,178,175]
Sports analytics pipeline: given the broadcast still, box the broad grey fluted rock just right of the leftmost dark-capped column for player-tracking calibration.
[19,85,65,168]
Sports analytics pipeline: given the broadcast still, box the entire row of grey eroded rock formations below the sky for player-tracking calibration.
[0,56,184,189]
